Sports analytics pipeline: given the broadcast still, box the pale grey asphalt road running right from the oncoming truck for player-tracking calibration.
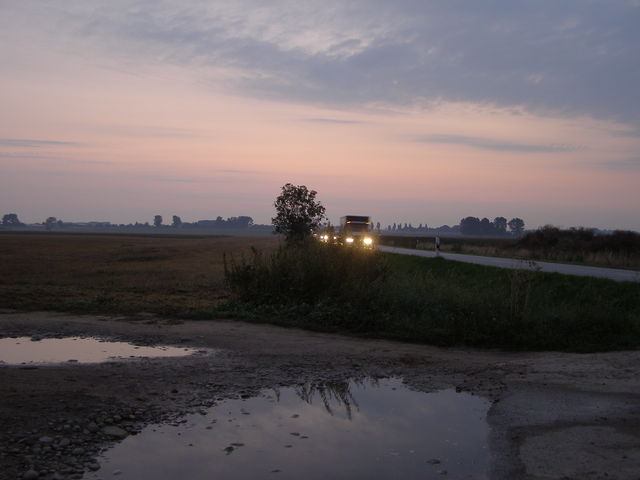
[378,245,640,282]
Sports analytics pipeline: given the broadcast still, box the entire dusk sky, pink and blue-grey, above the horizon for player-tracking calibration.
[0,0,640,230]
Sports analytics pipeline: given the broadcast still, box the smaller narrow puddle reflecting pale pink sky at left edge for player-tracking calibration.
[0,337,199,365]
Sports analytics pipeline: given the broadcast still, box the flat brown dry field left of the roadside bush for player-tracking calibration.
[0,234,279,315]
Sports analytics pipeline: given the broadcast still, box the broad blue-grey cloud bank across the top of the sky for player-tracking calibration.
[3,0,640,125]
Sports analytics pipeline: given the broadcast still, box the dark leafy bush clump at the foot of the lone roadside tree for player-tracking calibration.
[225,240,389,325]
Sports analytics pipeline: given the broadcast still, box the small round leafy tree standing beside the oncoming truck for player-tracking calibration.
[271,183,325,241]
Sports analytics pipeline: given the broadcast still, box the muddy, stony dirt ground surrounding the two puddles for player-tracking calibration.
[0,313,640,479]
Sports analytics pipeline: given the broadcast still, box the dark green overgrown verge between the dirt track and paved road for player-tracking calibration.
[226,243,640,351]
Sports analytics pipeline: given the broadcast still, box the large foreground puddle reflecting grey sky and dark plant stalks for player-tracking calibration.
[85,379,489,480]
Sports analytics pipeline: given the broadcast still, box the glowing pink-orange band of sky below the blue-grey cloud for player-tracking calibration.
[0,2,640,230]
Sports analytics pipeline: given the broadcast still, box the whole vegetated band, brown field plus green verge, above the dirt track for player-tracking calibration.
[0,234,640,351]
